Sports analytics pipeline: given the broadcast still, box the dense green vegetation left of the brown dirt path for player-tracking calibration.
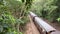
[0,0,32,34]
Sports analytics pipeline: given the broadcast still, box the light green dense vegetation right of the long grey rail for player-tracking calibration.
[31,0,60,22]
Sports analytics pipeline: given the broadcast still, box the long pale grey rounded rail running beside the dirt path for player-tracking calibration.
[30,12,60,34]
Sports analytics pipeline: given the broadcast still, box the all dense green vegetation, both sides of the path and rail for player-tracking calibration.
[0,0,60,34]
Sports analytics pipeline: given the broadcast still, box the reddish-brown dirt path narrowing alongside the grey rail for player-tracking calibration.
[25,16,40,34]
